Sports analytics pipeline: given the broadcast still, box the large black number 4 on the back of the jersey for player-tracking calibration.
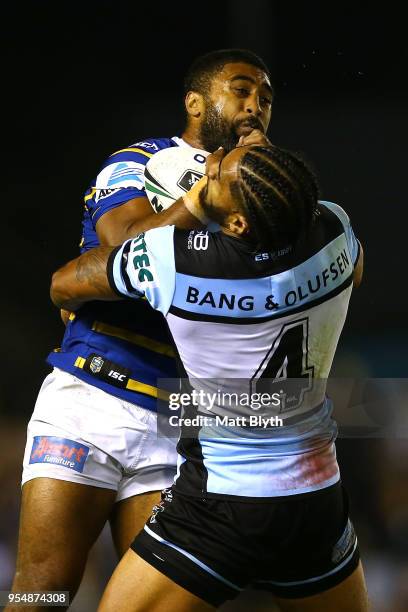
[251,318,314,412]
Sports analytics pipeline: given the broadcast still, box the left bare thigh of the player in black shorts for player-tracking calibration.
[98,550,214,612]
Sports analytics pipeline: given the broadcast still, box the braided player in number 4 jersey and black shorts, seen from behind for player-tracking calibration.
[51,146,368,612]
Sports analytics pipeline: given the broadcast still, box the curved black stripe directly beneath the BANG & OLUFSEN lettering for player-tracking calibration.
[169,274,353,325]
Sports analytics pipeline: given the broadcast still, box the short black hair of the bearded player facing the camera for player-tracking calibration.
[184,49,270,96]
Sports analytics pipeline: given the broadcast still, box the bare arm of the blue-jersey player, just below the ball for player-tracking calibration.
[96,197,155,246]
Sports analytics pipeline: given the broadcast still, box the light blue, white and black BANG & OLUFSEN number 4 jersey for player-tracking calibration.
[108,202,359,498]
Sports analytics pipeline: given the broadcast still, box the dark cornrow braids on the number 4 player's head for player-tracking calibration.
[239,146,319,250]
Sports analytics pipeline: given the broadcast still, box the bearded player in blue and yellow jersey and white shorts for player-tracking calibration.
[8,49,272,610]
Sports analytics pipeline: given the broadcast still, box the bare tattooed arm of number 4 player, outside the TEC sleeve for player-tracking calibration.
[50,247,120,311]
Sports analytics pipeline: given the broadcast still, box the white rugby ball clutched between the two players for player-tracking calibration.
[144,147,209,213]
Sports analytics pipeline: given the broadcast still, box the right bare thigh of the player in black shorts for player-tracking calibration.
[276,562,369,612]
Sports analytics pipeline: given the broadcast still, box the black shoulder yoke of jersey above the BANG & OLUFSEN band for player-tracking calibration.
[174,204,344,279]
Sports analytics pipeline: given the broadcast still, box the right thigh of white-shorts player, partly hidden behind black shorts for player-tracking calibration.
[109,491,160,557]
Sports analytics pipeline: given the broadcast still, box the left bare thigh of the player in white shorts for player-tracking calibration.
[14,478,116,589]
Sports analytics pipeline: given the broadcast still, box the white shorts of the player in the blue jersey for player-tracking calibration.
[22,368,177,501]
